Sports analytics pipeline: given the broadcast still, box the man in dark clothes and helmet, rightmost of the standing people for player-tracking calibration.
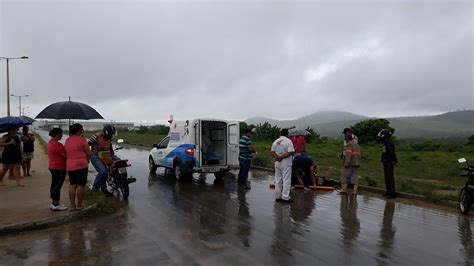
[377,129,398,199]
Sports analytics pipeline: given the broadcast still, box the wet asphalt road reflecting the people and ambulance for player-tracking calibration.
[0,144,474,265]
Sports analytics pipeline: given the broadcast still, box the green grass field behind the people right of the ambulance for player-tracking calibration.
[253,140,474,201]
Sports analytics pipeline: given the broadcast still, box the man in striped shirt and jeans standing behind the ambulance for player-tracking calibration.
[237,129,255,189]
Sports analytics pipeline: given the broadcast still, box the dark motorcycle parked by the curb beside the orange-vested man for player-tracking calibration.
[107,139,136,199]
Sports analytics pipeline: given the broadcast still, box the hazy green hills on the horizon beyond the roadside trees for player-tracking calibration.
[247,110,474,139]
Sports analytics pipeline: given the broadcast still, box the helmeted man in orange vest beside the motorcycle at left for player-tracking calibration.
[88,125,116,196]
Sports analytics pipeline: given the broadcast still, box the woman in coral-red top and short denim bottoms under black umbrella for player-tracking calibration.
[64,124,91,211]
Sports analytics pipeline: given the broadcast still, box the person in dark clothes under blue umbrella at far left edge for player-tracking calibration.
[0,127,24,187]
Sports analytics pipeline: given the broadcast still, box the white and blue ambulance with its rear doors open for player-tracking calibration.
[148,119,240,180]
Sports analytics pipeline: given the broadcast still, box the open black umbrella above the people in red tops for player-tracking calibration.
[35,101,104,120]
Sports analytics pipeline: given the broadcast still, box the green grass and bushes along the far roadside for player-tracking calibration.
[92,119,474,202]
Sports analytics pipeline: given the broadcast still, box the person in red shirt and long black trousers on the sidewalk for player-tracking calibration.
[48,128,67,211]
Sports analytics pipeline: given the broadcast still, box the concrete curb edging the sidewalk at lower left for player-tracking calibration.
[0,205,96,236]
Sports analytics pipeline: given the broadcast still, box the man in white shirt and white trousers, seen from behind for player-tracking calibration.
[271,129,295,203]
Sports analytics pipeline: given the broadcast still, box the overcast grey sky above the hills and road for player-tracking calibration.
[0,0,474,122]
